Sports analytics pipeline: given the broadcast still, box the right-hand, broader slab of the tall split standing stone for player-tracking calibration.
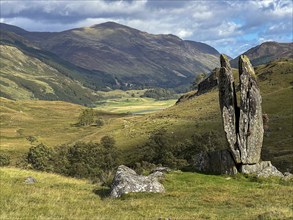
[237,56,264,164]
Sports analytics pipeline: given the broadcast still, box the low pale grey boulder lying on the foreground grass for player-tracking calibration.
[110,165,165,198]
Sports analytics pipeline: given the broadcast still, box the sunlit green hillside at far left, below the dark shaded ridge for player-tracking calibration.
[0,45,97,104]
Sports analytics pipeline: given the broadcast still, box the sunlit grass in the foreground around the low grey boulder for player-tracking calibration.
[0,168,293,219]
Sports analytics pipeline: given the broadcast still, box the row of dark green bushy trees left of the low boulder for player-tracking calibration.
[26,136,120,184]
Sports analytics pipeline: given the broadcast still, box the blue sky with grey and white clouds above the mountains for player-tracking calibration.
[0,0,293,57]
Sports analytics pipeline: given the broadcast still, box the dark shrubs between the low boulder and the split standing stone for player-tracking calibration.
[132,129,223,171]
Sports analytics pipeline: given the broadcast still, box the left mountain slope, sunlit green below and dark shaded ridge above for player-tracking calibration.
[0,29,121,104]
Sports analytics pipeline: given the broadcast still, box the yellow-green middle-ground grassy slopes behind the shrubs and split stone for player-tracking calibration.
[0,60,293,171]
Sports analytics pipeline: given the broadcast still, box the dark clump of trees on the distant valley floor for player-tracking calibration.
[141,88,178,100]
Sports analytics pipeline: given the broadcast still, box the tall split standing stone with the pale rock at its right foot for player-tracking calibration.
[218,55,283,177]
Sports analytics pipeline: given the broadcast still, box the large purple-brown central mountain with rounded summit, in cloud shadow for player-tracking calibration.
[1,22,219,88]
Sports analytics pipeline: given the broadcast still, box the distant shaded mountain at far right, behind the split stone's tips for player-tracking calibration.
[230,42,293,68]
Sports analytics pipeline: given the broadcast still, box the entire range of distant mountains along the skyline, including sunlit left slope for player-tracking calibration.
[0,22,293,104]
